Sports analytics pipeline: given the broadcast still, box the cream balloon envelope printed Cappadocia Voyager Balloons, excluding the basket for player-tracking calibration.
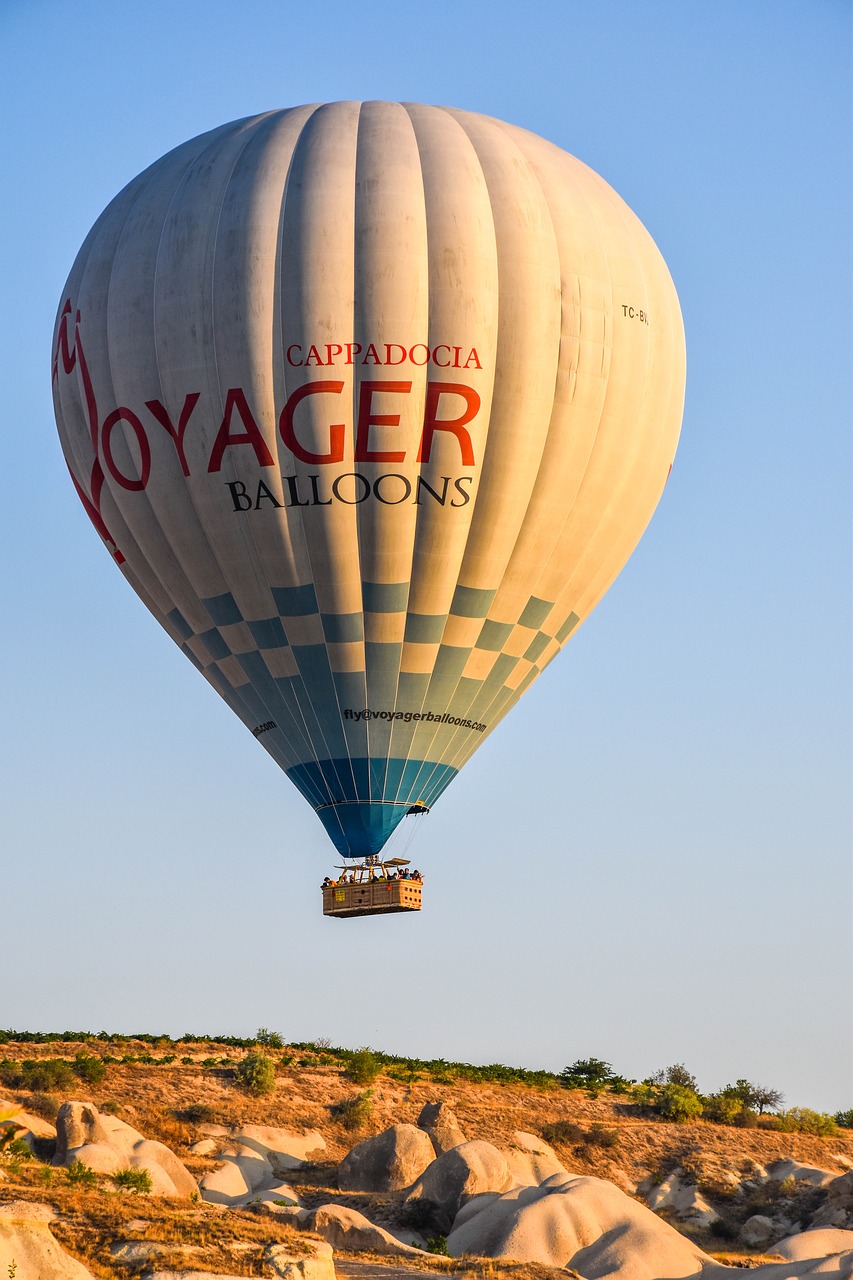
[53,102,685,911]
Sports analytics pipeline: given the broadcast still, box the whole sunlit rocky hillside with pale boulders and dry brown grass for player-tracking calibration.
[0,1038,853,1280]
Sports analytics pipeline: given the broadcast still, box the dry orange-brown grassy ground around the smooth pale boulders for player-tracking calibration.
[0,1042,853,1280]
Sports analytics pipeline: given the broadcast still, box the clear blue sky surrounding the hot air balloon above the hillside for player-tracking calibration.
[0,0,853,1110]
